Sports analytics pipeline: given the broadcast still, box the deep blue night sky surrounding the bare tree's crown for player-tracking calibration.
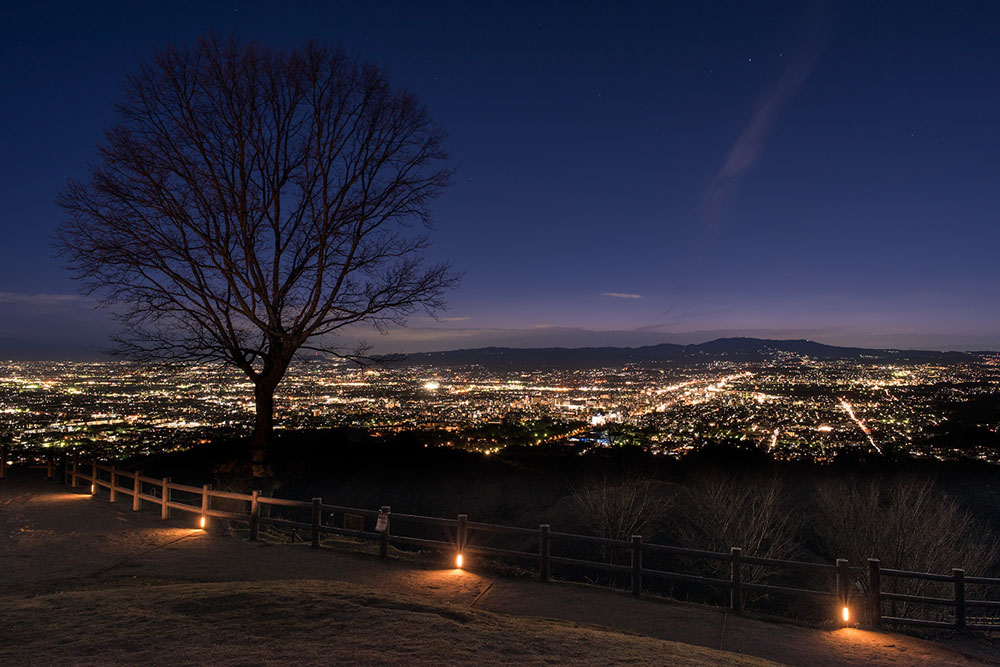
[0,1,1000,358]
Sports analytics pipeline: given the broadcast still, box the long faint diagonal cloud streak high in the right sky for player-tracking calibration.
[704,4,832,227]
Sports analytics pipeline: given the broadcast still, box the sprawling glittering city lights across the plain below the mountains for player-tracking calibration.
[0,353,1000,468]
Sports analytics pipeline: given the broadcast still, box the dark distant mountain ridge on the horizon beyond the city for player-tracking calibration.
[396,338,980,368]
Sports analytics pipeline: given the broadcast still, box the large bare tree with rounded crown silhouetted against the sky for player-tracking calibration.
[56,38,456,476]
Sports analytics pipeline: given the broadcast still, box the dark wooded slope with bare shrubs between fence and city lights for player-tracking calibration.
[105,429,1000,619]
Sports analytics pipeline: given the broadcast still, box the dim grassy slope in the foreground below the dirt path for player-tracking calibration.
[0,580,771,665]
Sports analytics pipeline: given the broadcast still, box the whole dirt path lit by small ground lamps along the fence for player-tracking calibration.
[0,474,1000,665]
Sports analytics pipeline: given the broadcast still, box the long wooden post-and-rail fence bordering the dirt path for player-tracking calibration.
[7,448,1000,631]
